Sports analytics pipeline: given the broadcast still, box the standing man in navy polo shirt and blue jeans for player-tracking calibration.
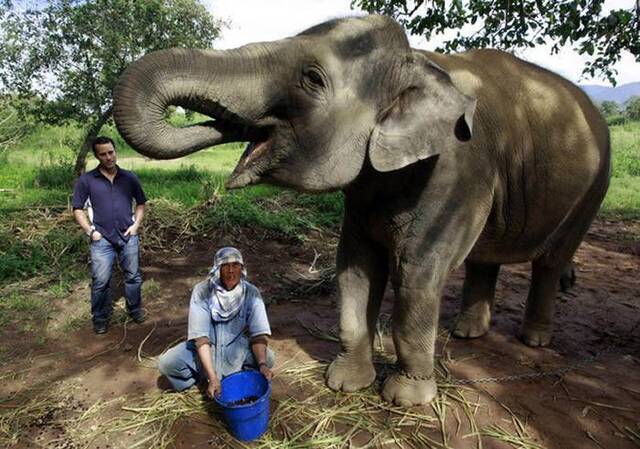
[72,136,147,334]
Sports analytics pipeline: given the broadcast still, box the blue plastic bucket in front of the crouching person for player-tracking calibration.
[215,371,271,441]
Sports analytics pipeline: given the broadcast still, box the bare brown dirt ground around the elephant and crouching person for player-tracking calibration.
[0,215,640,449]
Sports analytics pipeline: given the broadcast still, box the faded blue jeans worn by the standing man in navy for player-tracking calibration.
[89,235,142,325]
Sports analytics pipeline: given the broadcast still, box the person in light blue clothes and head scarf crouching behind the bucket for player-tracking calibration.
[158,247,274,398]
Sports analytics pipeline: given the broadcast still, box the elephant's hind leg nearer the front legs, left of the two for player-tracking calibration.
[453,262,500,338]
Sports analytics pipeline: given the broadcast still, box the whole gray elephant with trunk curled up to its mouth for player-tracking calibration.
[114,16,610,406]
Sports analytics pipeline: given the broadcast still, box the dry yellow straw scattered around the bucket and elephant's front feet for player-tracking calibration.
[82,357,542,449]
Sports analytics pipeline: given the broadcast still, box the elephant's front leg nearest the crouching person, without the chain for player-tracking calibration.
[325,222,388,391]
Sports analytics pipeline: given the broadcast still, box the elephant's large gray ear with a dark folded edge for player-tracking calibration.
[369,53,476,172]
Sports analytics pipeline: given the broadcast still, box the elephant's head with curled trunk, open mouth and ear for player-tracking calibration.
[114,15,475,191]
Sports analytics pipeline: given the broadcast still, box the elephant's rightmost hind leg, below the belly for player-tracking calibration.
[520,260,566,347]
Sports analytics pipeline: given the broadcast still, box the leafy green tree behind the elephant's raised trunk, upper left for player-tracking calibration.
[0,0,223,173]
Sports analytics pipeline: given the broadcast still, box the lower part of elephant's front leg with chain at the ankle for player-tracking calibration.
[382,287,440,407]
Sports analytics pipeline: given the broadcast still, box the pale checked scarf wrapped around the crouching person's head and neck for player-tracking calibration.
[209,246,247,321]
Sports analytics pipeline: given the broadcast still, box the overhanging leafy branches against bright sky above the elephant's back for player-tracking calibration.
[351,0,640,85]
